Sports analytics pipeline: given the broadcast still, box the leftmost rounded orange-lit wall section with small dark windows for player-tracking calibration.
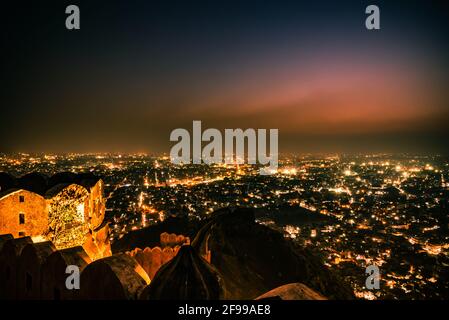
[0,190,48,238]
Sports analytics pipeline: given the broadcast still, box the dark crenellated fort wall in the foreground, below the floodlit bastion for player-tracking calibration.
[0,233,190,300]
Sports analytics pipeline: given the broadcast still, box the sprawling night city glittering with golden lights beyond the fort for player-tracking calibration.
[0,153,449,299]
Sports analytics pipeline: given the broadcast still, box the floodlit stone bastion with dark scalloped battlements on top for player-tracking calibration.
[0,172,111,259]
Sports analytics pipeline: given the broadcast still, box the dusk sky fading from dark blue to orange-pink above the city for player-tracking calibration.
[0,0,449,152]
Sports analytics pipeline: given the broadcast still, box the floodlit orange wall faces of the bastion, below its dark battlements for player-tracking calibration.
[0,179,112,260]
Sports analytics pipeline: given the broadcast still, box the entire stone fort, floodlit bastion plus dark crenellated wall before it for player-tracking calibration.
[0,173,198,300]
